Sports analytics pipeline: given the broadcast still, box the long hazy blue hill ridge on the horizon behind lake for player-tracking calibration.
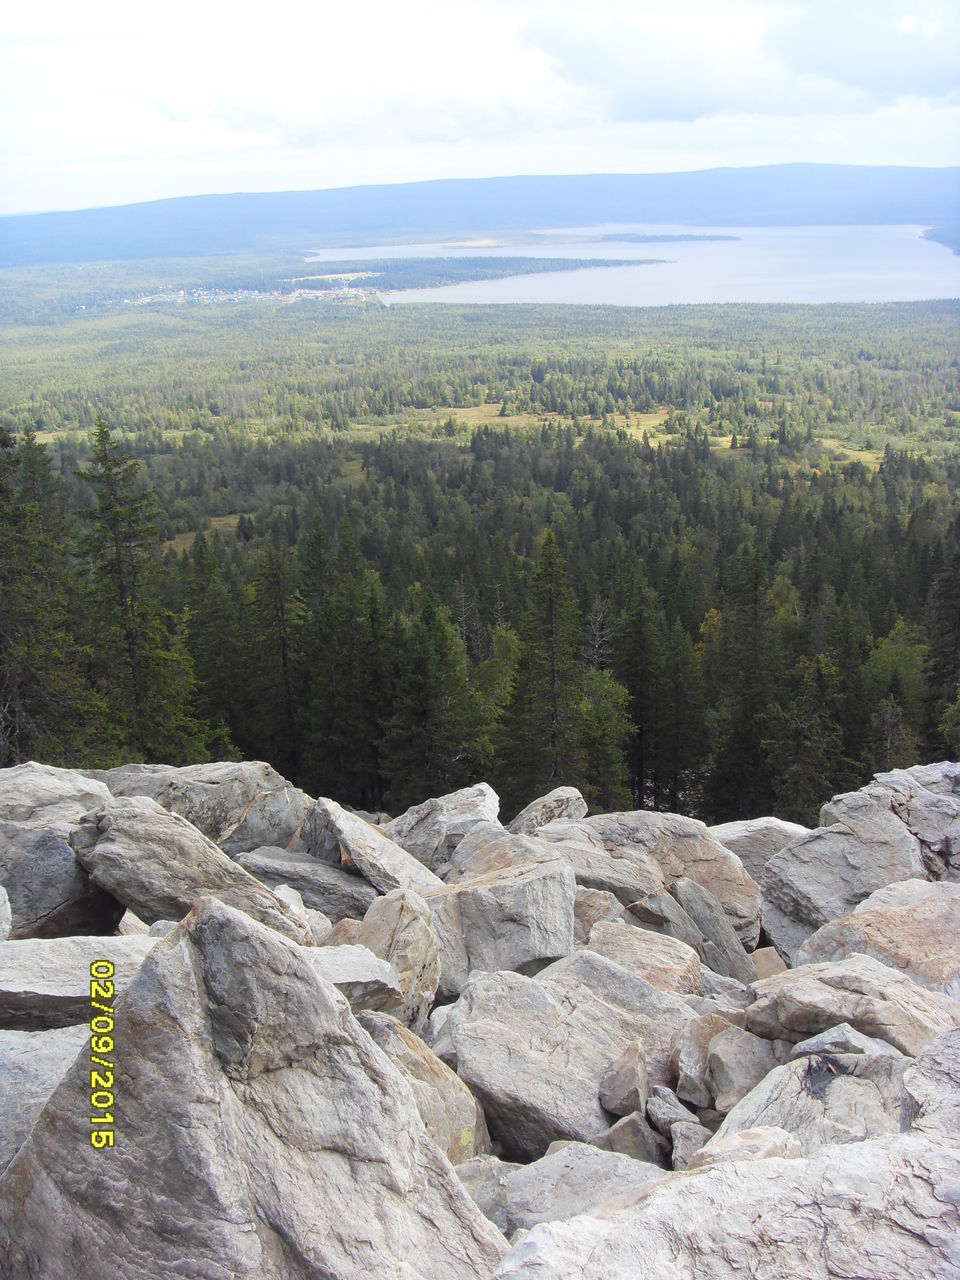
[0,164,960,266]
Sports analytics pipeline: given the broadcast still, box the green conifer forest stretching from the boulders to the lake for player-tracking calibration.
[0,294,960,823]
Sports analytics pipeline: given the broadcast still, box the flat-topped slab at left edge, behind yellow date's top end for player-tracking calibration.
[0,937,156,1030]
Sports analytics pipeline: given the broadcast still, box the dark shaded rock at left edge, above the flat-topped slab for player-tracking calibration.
[0,819,123,938]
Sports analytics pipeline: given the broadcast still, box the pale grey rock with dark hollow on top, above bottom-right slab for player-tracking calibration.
[714,1053,908,1156]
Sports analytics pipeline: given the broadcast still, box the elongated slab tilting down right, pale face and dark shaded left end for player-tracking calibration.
[302,799,443,893]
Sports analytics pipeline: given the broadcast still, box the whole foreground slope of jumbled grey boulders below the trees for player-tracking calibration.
[0,763,960,1280]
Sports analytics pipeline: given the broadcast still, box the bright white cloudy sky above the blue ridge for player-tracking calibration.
[0,0,960,214]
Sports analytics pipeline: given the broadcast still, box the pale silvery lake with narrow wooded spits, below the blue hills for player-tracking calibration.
[309,224,960,306]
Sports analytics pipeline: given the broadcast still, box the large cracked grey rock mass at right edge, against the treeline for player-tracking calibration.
[762,764,960,963]
